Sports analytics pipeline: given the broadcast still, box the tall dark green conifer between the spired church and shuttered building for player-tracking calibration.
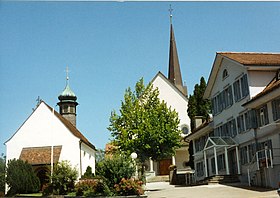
[188,77,211,130]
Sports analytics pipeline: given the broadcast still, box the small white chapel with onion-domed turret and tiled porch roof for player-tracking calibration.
[5,74,96,190]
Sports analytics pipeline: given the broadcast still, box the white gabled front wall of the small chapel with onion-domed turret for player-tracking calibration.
[6,103,80,174]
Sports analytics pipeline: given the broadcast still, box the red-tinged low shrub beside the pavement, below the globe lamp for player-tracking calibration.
[115,178,144,196]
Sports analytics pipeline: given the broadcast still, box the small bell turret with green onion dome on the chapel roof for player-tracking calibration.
[57,68,78,127]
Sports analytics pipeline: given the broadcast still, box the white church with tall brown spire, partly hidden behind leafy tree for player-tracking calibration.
[146,16,190,176]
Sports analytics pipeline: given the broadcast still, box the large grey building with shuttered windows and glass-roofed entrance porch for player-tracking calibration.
[187,52,280,187]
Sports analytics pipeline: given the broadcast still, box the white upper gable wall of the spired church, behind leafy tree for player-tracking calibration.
[152,75,190,130]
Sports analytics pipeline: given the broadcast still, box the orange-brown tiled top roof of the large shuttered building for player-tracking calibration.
[217,52,280,66]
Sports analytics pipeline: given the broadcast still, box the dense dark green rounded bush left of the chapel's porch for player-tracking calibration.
[6,159,40,196]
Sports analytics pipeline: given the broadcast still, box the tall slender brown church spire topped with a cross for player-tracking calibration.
[168,5,187,96]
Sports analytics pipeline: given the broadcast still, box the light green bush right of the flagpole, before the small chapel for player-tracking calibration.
[43,161,78,195]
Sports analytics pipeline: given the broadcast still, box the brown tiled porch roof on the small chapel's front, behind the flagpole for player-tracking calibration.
[19,146,62,165]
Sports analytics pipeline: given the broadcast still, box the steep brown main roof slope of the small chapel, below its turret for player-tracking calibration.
[44,102,96,150]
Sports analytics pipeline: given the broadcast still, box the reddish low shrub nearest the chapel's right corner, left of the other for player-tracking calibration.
[75,177,112,197]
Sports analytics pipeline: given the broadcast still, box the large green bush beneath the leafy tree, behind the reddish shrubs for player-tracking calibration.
[96,155,135,189]
